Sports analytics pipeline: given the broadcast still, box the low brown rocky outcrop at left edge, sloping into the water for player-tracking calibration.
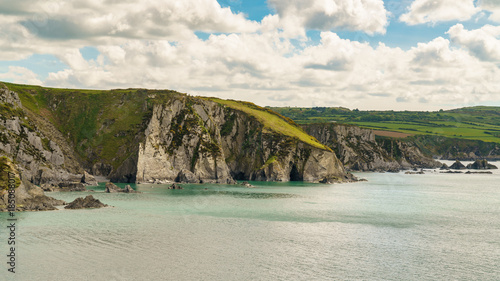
[0,157,66,211]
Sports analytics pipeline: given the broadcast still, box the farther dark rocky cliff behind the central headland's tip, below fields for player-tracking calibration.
[303,123,441,171]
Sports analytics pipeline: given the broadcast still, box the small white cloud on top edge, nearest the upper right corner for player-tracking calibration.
[399,0,480,25]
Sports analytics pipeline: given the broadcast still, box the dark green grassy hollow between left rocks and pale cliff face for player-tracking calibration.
[4,83,164,166]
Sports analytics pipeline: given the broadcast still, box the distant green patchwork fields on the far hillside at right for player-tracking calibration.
[273,107,500,143]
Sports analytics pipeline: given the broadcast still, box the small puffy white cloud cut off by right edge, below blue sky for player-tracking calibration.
[447,24,500,61]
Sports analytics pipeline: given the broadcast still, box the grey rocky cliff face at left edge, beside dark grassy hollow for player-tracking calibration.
[0,84,83,184]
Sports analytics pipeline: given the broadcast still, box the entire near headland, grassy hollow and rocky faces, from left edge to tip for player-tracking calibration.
[0,83,354,184]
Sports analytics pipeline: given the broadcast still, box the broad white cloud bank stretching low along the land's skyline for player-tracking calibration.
[39,29,500,110]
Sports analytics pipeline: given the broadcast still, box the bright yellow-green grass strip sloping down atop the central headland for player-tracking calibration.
[208,98,330,151]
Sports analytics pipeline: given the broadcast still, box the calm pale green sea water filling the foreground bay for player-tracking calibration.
[0,163,500,280]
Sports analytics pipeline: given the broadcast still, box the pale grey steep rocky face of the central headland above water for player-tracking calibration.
[136,96,352,183]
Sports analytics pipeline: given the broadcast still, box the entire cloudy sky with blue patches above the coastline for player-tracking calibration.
[0,0,500,110]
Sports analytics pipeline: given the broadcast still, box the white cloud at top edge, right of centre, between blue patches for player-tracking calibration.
[269,0,388,36]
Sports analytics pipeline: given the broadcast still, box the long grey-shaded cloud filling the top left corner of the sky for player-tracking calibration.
[0,0,259,40]
